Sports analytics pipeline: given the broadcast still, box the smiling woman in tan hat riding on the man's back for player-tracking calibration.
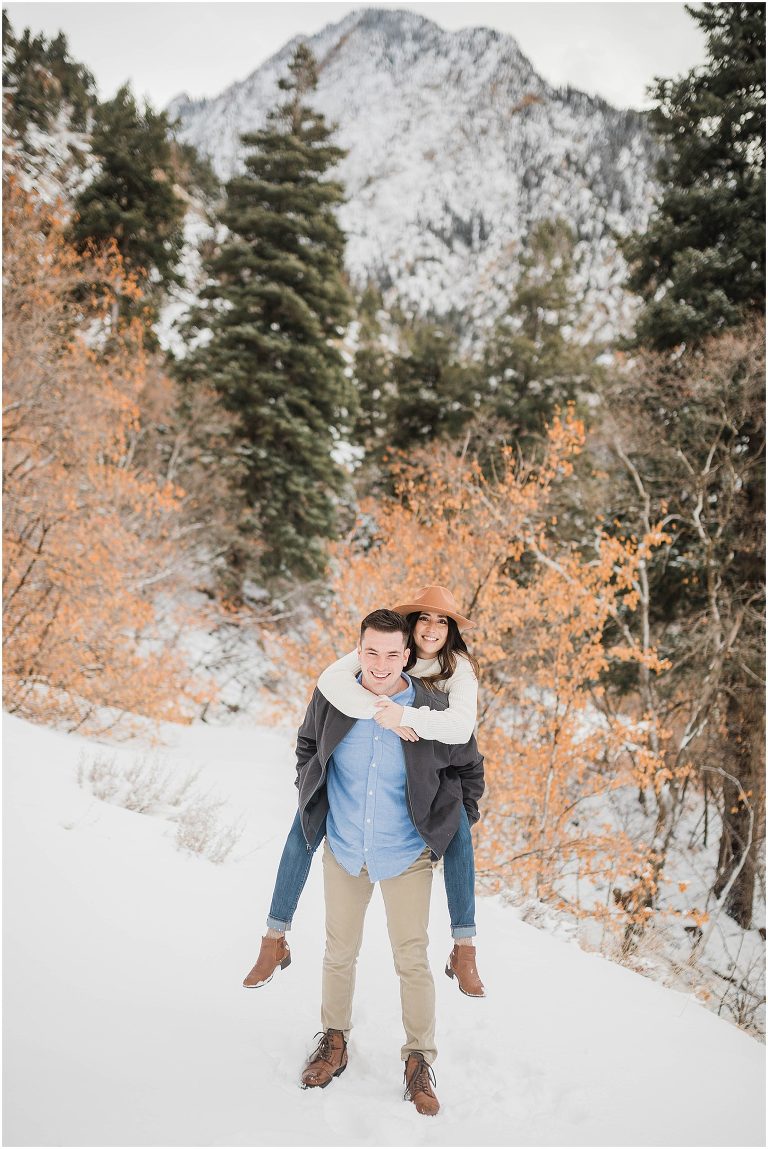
[243,586,485,997]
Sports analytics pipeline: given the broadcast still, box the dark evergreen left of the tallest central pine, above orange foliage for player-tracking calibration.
[71,85,184,305]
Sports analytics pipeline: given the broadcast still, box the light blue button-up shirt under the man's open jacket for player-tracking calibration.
[325,674,425,881]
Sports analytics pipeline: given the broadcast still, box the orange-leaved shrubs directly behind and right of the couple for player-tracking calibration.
[279,410,685,928]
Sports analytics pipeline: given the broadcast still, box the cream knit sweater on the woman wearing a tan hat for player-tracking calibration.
[317,650,477,746]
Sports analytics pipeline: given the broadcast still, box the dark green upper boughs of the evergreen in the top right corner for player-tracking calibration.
[625,3,766,349]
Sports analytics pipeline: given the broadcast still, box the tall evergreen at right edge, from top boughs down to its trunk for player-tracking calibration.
[624,3,766,926]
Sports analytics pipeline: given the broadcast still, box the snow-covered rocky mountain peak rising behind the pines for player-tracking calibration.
[169,8,653,337]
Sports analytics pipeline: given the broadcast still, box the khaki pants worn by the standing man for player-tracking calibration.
[321,841,437,1065]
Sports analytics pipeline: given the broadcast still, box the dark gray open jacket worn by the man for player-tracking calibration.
[295,678,485,858]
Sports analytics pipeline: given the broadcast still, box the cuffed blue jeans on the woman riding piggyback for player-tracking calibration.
[267,805,476,938]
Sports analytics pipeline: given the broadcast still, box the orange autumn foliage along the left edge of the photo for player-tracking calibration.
[3,177,210,730]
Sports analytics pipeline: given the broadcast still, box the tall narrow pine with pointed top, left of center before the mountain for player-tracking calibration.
[179,45,350,578]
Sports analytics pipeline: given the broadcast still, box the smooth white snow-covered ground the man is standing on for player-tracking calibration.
[3,718,765,1146]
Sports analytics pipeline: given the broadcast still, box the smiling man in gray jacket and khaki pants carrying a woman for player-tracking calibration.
[297,610,484,1115]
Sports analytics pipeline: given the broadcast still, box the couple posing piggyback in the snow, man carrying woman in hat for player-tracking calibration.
[244,586,484,1115]
